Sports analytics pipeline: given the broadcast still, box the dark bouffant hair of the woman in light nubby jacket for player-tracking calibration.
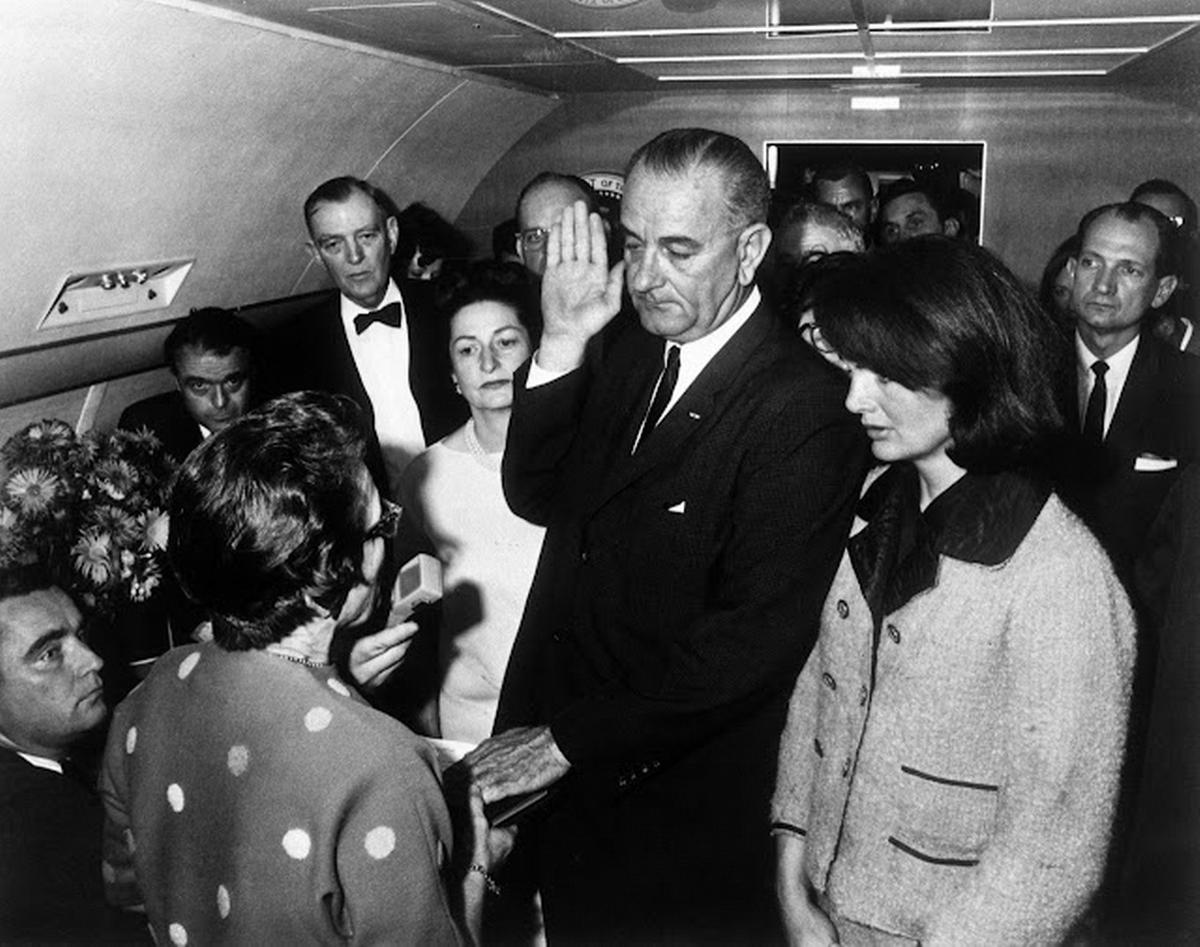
[814,236,1064,472]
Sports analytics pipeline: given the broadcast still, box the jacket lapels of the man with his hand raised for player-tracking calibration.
[594,305,772,509]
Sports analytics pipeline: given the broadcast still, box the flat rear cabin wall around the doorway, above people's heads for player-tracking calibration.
[458,89,1200,282]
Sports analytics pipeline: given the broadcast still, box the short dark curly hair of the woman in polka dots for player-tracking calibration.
[167,391,368,651]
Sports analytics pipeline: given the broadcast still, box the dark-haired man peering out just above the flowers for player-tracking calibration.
[118,307,256,463]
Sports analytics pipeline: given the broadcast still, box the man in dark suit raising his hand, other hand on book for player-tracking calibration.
[467,128,866,943]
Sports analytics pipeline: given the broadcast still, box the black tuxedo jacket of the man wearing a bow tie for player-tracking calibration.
[265,280,468,495]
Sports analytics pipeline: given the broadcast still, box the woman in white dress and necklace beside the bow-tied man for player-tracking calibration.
[401,263,544,743]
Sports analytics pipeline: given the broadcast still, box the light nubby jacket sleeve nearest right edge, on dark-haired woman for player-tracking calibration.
[922,525,1134,947]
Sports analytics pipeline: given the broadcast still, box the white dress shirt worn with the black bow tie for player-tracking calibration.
[342,280,425,496]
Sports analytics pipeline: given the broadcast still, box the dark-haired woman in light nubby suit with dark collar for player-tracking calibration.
[773,238,1134,945]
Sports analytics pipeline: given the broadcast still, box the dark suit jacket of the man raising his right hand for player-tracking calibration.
[496,301,866,941]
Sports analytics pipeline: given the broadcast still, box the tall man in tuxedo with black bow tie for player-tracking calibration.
[270,178,467,496]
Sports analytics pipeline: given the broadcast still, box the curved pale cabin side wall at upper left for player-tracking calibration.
[0,0,557,403]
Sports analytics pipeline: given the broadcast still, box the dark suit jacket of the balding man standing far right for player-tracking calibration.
[1062,332,1200,587]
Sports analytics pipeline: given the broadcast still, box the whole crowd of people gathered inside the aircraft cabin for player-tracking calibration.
[0,128,1200,947]
